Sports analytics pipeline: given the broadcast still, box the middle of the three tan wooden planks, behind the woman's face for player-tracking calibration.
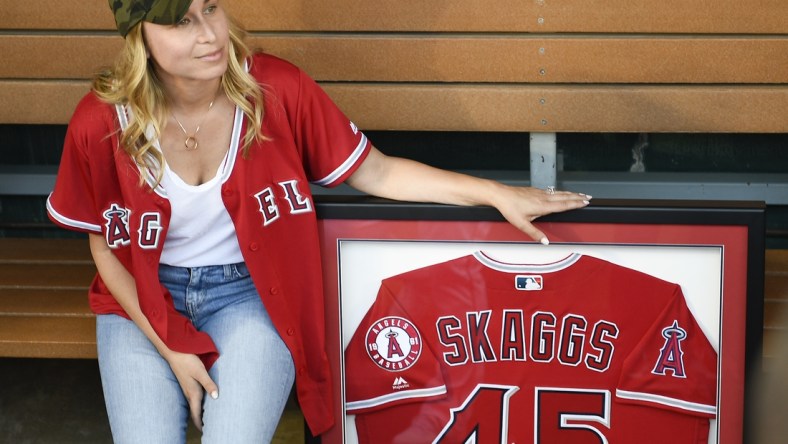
[0,35,788,83]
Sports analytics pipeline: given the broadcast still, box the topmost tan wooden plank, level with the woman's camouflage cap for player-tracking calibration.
[0,0,788,34]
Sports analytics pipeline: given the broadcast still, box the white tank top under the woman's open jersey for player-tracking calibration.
[161,150,243,267]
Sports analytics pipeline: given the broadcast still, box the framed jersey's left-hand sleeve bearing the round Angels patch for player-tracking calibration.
[345,281,446,414]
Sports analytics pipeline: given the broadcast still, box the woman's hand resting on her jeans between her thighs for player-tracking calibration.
[164,350,219,431]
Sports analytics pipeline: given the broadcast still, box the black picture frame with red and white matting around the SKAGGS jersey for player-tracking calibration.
[309,202,765,444]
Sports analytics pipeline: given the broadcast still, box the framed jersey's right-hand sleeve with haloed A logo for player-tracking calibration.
[616,285,717,418]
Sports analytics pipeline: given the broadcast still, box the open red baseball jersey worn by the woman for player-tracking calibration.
[47,54,371,433]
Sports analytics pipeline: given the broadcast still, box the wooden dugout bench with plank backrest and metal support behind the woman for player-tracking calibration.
[0,0,788,374]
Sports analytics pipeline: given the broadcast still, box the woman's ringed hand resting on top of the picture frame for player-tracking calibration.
[492,184,591,245]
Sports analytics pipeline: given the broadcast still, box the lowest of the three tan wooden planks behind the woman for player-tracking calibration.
[0,81,788,133]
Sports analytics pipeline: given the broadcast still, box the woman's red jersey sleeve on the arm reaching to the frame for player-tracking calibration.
[295,70,371,187]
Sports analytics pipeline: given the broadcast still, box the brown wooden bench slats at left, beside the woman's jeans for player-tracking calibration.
[0,238,96,358]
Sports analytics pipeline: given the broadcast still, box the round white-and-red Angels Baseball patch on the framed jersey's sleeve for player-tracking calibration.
[366,316,421,372]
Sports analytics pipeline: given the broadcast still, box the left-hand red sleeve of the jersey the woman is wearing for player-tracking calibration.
[47,93,111,233]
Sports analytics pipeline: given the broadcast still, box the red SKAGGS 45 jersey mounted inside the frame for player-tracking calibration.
[345,252,717,444]
